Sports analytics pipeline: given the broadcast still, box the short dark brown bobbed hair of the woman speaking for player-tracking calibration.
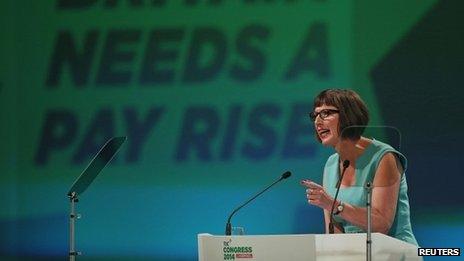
[313,89,369,141]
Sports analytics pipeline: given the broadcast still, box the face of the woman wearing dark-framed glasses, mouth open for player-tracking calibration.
[314,104,339,147]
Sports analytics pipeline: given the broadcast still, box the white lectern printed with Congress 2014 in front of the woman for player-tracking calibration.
[198,233,422,261]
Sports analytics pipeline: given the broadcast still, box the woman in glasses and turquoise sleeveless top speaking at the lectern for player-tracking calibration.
[302,89,417,245]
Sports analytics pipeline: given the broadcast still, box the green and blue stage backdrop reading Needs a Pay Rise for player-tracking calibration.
[0,0,464,260]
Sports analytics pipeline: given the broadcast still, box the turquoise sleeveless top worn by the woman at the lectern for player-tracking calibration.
[323,139,418,245]
